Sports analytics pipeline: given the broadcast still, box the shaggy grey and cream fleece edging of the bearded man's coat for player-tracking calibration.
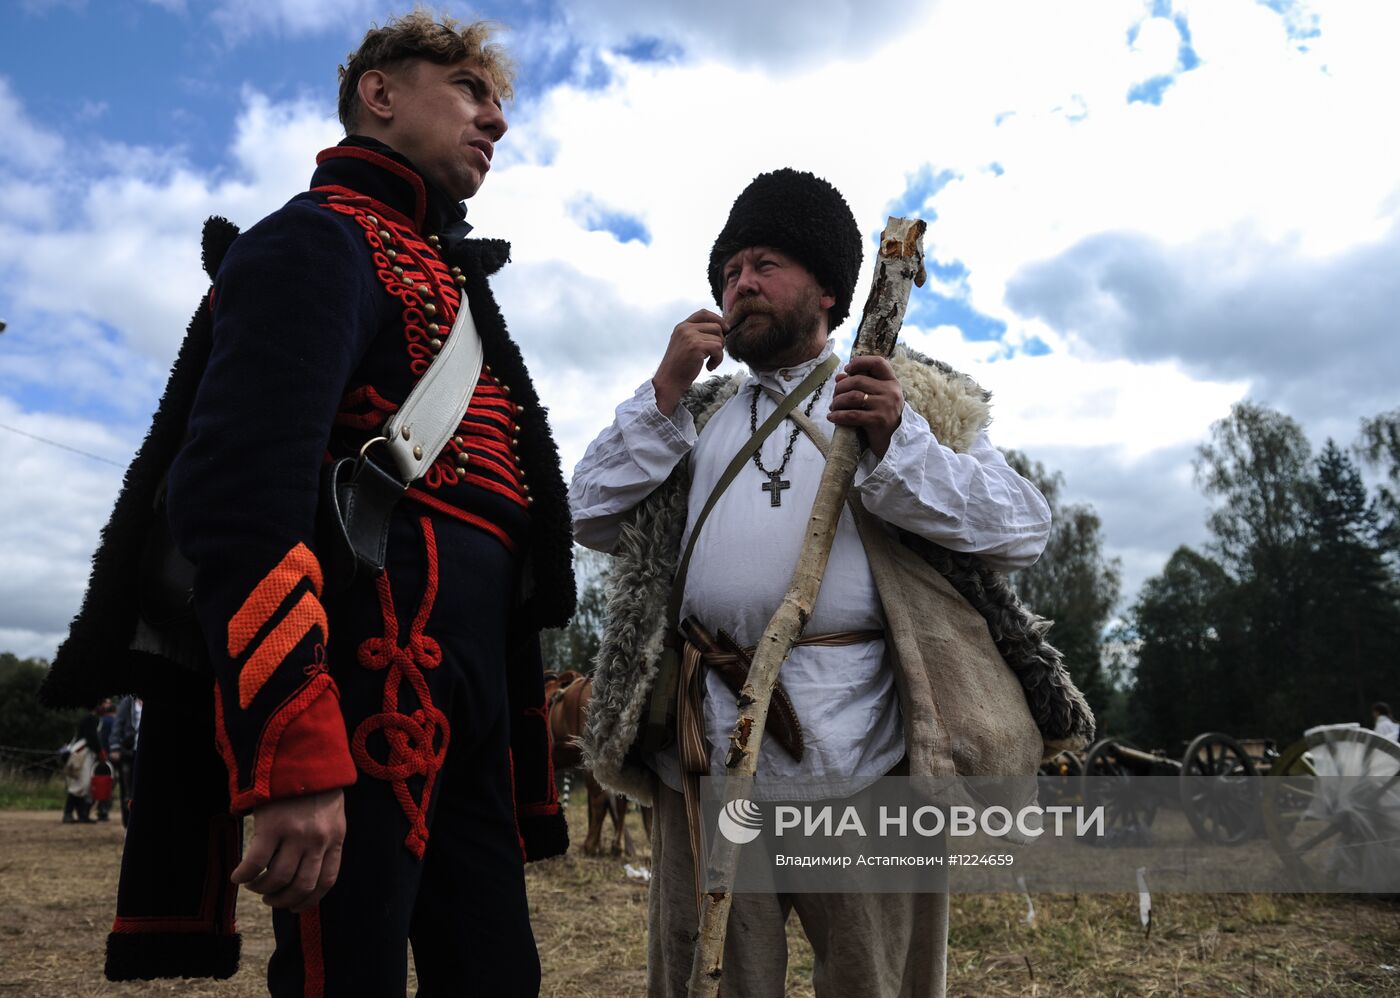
[584,346,1093,803]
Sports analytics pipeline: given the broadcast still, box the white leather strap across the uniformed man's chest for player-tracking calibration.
[384,293,482,483]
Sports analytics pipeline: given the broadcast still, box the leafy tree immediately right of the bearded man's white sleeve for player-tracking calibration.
[1007,451,1120,715]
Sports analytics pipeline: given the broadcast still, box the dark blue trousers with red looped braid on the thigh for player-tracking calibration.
[267,515,539,998]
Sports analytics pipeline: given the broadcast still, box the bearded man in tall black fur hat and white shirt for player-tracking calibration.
[570,169,1086,998]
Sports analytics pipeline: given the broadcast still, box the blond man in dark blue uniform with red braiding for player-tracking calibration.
[45,11,574,997]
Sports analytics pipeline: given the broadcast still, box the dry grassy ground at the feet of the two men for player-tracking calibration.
[0,810,1400,998]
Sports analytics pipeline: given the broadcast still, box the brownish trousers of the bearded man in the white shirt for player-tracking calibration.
[647,781,948,998]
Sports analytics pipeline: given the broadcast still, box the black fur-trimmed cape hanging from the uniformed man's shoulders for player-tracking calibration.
[42,198,575,980]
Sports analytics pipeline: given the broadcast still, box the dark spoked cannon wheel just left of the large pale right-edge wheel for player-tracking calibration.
[1182,732,1259,845]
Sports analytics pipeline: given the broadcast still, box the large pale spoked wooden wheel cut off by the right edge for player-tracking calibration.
[1263,725,1400,890]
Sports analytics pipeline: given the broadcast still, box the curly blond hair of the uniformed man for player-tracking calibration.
[336,10,515,134]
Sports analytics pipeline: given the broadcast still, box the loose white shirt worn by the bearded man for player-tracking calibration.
[568,344,1050,801]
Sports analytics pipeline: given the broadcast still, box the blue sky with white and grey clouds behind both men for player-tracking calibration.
[0,0,1400,655]
